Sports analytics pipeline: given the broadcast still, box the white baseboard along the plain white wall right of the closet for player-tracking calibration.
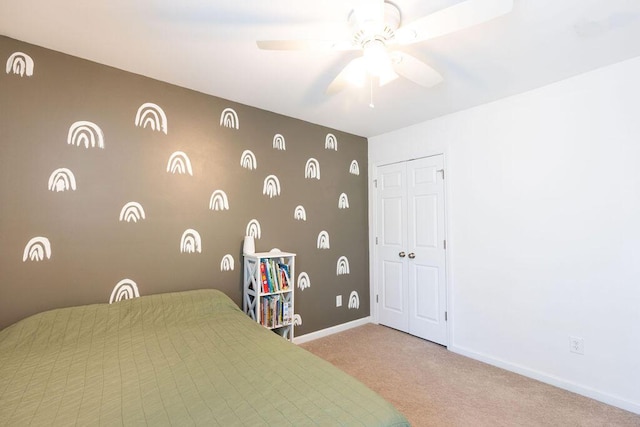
[448,345,640,414]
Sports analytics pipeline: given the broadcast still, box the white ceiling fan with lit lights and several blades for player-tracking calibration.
[257,0,513,94]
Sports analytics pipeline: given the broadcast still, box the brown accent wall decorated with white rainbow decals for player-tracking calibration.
[0,37,369,335]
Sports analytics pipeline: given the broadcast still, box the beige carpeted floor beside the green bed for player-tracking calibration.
[300,324,640,427]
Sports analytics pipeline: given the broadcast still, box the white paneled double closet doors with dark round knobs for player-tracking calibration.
[376,155,447,345]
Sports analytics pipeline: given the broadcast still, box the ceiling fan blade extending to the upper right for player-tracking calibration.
[396,0,513,44]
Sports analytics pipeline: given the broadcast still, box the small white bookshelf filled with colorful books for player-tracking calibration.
[242,251,296,341]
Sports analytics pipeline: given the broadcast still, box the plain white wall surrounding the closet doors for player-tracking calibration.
[369,58,640,413]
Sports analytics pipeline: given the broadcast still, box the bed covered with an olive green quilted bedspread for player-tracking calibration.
[0,289,409,426]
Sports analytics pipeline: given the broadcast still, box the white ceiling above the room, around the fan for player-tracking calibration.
[0,0,640,137]
